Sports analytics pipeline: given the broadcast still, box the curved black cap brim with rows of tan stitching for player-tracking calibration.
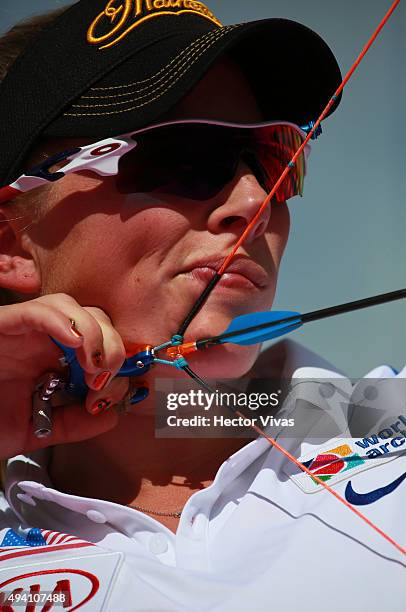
[43,19,342,137]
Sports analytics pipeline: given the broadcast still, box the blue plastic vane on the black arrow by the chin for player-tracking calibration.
[221,310,302,346]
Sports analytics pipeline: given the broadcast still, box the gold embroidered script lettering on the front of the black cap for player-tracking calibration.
[87,0,222,49]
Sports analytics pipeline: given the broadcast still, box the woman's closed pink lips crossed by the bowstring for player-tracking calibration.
[182,256,270,289]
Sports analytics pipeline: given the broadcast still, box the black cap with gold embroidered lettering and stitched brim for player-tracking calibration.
[0,0,341,185]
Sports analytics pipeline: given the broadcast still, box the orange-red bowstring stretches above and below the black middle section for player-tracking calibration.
[224,0,406,555]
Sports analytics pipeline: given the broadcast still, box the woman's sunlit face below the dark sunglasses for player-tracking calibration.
[30,59,289,378]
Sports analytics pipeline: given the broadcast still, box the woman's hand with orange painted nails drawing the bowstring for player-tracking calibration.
[0,293,129,459]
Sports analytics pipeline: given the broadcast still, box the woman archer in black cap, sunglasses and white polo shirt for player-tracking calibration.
[0,0,400,610]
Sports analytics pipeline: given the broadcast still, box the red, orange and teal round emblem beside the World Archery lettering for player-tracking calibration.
[302,444,365,486]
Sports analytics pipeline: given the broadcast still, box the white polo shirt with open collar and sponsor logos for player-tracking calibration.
[0,366,406,612]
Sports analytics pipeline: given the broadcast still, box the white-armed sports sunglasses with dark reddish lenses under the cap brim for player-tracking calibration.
[0,120,310,204]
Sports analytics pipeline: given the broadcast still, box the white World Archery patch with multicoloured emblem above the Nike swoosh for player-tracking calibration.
[283,438,398,493]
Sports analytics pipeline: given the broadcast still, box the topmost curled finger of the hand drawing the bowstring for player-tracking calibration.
[0,300,83,348]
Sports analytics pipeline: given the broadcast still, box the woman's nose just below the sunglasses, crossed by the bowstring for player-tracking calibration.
[208,160,271,244]
